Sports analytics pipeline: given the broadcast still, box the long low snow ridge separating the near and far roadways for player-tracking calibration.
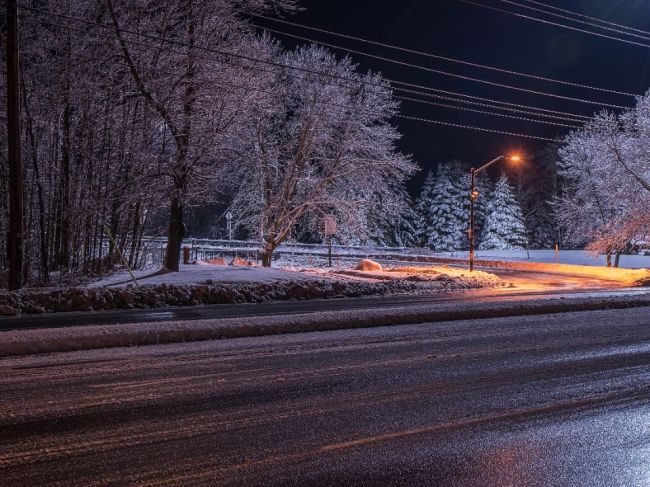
[0,295,650,357]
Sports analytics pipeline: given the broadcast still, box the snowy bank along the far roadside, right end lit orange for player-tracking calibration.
[0,265,506,316]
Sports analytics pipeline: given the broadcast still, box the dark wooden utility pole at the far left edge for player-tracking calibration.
[6,0,24,289]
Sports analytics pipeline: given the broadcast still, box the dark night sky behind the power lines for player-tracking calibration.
[252,0,650,192]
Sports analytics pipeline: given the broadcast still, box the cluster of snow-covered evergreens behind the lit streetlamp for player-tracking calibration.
[415,155,560,252]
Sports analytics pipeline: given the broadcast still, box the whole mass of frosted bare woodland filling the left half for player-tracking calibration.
[0,0,416,283]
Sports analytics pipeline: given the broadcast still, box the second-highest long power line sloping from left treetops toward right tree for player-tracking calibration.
[257,23,629,110]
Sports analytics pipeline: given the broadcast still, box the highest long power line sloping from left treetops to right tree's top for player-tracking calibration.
[246,12,637,97]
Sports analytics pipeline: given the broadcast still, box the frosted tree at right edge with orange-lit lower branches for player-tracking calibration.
[554,92,650,265]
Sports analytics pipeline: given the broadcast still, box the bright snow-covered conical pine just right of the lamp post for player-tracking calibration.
[479,174,528,250]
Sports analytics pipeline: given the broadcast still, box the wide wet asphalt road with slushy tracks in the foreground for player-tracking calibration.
[0,308,650,487]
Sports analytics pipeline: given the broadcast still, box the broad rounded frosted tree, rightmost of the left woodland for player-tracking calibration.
[232,46,416,266]
